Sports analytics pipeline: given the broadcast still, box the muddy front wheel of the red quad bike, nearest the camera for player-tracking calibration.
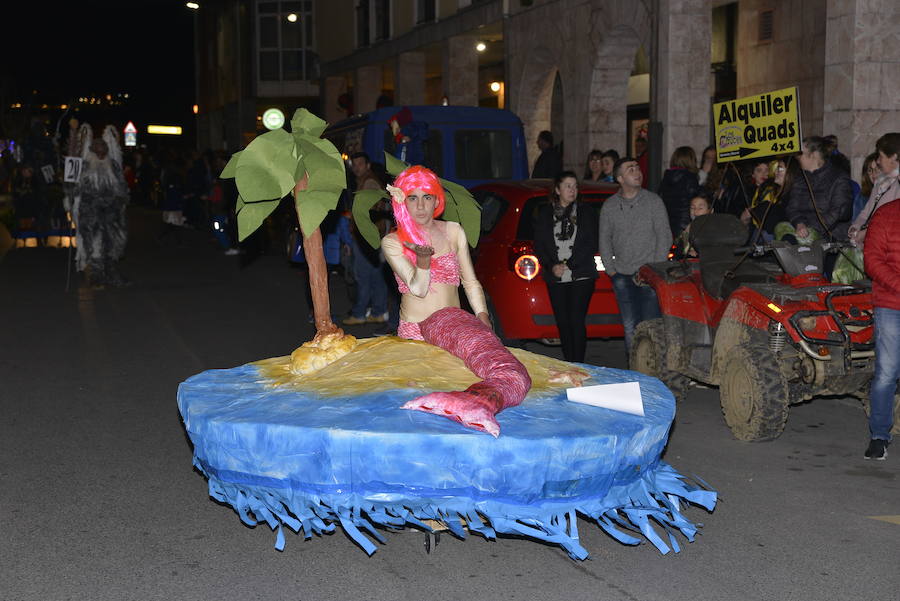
[719,344,789,442]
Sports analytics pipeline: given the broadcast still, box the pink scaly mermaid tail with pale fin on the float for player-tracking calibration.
[401,307,531,438]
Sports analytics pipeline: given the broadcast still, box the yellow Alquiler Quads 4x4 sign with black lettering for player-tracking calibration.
[713,88,800,163]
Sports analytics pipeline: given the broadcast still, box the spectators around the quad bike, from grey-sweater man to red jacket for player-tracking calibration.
[572,132,900,460]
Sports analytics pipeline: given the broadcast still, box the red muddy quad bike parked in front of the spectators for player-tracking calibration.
[630,214,875,441]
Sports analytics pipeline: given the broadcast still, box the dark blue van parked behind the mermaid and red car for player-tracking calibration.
[322,105,528,188]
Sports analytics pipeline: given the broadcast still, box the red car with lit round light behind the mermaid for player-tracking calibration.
[472,179,624,341]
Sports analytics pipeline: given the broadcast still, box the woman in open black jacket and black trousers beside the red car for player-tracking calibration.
[534,171,600,363]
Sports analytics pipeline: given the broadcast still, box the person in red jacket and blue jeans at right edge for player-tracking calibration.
[864,198,900,460]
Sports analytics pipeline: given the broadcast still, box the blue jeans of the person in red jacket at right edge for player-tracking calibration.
[869,307,900,440]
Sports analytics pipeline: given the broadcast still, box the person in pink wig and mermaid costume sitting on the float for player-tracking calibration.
[382,166,531,436]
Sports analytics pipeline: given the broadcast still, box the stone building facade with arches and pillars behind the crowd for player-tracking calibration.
[198,0,900,178]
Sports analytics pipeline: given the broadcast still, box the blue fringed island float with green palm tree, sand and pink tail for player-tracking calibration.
[178,109,716,559]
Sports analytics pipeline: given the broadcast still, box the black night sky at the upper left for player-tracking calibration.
[0,0,195,123]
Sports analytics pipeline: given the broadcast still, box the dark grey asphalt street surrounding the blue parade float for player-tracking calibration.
[0,208,900,601]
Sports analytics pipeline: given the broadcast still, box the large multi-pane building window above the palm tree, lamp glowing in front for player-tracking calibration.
[256,0,319,81]
